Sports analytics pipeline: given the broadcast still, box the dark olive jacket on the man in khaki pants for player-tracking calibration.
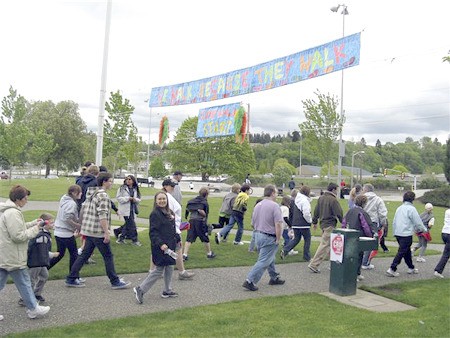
[312,191,343,229]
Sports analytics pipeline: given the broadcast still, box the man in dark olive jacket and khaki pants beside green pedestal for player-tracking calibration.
[308,183,343,273]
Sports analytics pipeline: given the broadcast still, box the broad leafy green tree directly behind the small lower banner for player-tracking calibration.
[168,117,256,181]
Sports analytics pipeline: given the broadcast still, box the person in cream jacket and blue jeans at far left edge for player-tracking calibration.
[0,185,50,319]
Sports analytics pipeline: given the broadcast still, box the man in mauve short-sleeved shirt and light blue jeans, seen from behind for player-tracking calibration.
[242,185,284,291]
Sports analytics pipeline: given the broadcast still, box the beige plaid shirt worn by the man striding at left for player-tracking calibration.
[81,187,111,238]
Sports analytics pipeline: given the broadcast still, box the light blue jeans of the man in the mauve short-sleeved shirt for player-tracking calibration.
[247,231,278,284]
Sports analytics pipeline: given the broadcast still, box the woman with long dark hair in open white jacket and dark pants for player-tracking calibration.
[116,175,142,246]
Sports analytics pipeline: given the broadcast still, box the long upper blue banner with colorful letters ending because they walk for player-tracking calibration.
[149,33,361,107]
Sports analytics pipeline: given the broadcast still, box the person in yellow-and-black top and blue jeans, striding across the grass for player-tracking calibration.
[215,184,250,245]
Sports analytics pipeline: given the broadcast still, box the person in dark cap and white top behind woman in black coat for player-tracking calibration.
[162,178,195,280]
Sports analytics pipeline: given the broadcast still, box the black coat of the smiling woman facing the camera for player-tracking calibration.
[149,207,179,266]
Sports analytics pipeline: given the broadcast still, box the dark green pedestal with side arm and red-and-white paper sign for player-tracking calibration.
[329,229,378,296]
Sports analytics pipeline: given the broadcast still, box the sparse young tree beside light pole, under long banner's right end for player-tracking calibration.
[299,91,345,177]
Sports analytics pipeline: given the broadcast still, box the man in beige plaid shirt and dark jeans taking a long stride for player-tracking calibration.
[66,172,131,289]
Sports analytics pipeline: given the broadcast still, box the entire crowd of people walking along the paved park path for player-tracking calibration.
[0,169,450,320]
